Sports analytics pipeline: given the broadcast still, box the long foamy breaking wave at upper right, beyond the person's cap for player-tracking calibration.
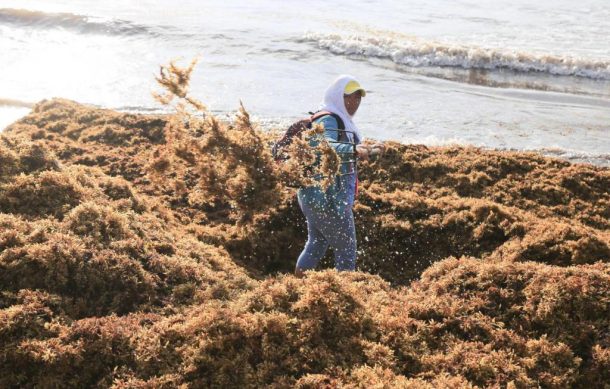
[299,32,610,80]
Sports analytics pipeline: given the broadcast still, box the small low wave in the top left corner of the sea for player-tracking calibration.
[0,8,158,35]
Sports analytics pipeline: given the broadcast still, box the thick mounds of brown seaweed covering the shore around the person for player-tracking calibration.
[0,94,610,388]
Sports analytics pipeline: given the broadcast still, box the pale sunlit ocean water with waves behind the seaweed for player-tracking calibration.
[0,0,610,166]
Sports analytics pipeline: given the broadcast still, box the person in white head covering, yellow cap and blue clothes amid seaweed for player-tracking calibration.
[295,74,383,278]
